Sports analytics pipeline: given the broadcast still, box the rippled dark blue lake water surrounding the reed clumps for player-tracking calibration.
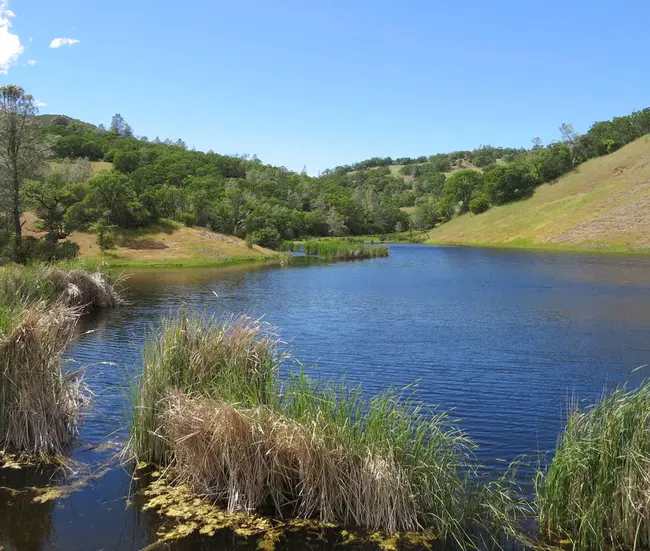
[0,245,650,550]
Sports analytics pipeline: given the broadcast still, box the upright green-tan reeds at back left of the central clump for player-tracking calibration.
[130,313,283,463]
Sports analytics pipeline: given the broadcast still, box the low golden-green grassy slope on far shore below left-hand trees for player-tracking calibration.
[24,212,277,267]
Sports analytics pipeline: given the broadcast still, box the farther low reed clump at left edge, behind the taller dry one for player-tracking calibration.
[0,264,123,308]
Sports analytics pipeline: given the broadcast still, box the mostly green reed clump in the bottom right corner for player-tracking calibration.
[536,382,650,550]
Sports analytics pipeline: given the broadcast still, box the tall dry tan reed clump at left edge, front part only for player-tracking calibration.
[0,302,85,455]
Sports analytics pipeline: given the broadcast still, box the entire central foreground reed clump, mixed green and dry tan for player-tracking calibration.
[130,314,512,542]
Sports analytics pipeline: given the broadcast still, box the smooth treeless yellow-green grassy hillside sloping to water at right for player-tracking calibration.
[428,136,650,252]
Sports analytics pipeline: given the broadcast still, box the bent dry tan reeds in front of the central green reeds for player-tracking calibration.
[165,390,426,532]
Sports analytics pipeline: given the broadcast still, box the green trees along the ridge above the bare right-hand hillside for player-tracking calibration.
[322,108,650,230]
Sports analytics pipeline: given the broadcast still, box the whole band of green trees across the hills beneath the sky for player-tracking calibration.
[0,86,650,261]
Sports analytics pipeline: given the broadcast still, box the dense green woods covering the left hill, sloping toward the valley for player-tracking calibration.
[31,116,413,248]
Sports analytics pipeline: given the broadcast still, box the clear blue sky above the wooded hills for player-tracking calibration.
[0,0,650,174]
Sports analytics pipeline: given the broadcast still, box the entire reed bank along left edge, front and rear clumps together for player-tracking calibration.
[0,265,122,456]
